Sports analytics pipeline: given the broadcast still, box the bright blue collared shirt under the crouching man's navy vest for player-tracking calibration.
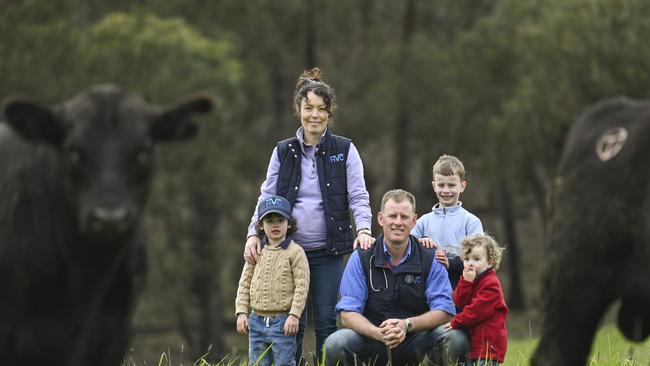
[336,242,456,315]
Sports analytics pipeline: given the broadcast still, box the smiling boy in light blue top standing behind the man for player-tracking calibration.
[412,155,483,289]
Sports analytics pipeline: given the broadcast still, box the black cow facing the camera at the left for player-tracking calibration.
[0,85,212,366]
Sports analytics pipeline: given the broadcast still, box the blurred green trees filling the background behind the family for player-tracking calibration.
[0,0,650,362]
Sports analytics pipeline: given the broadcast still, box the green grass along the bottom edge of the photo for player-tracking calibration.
[123,326,650,366]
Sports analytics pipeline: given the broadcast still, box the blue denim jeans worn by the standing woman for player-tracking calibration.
[296,252,345,364]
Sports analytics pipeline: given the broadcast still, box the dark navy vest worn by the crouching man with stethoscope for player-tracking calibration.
[357,235,435,326]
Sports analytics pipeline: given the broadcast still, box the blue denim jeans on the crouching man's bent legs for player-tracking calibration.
[325,326,470,366]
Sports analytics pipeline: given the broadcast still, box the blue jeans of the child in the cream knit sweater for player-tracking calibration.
[248,313,296,366]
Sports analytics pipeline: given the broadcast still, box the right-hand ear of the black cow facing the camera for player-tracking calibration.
[150,95,212,141]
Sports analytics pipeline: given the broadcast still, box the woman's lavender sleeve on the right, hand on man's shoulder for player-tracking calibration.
[346,143,372,230]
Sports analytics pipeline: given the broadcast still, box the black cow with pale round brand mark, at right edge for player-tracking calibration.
[532,98,650,366]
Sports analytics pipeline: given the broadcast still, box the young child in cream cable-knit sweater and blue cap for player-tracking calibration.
[235,196,309,365]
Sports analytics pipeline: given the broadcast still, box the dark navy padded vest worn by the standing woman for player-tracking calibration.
[276,129,355,255]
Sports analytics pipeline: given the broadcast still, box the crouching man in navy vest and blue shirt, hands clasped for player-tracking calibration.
[325,189,469,366]
